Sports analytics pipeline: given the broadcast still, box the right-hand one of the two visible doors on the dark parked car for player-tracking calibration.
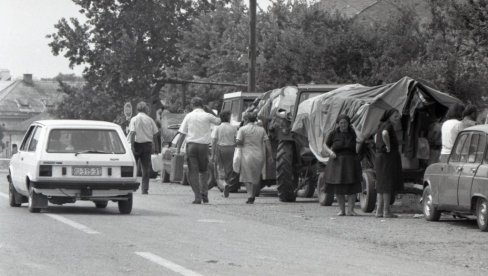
[458,132,486,211]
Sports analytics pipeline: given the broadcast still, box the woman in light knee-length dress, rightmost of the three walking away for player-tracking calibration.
[236,112,271,204]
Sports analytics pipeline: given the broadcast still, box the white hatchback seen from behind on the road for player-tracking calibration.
[7,120,140,214]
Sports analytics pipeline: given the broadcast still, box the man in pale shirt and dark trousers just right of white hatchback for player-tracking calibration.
[129,102,159,194]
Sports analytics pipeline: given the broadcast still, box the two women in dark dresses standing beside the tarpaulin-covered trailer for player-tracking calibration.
[323,109,403,218]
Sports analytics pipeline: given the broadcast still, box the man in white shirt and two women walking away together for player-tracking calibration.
[173,97,269,204]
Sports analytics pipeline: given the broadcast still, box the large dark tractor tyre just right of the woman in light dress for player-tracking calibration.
[276,141,298,202]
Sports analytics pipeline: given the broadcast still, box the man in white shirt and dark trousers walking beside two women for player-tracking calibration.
[176,97,220,204]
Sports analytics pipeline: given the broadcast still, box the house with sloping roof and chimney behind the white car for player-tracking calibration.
[0,74,83,158]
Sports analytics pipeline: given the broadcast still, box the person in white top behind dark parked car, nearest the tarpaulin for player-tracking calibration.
[440,103,464,162]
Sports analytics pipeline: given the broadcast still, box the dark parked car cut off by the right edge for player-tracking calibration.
[422,125,488,231]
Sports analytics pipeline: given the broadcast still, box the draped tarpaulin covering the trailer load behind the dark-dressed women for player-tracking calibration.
[292,77,460,162]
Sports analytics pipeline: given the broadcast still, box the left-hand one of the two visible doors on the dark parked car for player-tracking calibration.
[439,132,471,209]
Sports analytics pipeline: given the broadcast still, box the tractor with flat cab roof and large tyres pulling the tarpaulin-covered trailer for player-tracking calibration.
[252,84,343,202]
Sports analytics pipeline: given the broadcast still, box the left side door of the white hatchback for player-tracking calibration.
[10,126,36,192]
